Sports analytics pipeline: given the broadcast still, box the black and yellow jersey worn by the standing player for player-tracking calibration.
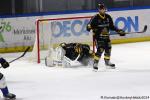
[87,13,118,38]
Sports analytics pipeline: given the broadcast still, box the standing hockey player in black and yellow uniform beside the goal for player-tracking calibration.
[87,4,125,70]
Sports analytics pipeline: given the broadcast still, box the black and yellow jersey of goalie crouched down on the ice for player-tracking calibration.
[60,43,92,66]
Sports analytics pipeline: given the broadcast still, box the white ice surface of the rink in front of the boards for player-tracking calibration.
[0,42,150,100]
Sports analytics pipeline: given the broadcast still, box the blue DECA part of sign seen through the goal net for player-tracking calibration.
[53,18,89,37]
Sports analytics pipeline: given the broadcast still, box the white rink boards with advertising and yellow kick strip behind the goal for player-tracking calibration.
[0,9,150,52]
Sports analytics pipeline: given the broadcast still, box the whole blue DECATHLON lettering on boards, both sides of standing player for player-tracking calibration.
[53,16,139,38]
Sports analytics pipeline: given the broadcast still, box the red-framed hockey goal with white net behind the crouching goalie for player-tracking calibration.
[31,16,92,63]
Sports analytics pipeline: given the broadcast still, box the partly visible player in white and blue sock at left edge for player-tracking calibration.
[0,58,16,100]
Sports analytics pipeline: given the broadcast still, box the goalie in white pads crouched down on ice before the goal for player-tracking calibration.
[45,43,93,67]
